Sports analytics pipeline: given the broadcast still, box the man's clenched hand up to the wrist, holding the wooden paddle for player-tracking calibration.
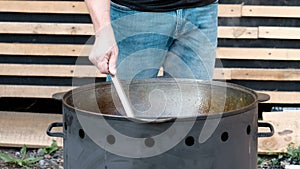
[89,24,119,76]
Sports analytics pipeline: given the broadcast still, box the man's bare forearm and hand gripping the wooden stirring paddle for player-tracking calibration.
[85,0,118,76]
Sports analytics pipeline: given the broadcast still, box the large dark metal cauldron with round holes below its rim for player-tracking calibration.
[47,78,274,169]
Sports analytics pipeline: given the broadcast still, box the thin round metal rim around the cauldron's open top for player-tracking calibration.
[62,78,258,122]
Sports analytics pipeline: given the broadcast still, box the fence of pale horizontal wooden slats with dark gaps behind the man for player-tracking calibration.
[0,0,300,152]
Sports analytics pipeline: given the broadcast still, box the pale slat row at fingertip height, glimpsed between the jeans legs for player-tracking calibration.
[0,64,300,81]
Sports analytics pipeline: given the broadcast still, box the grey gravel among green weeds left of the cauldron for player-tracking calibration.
[0,148,64,169]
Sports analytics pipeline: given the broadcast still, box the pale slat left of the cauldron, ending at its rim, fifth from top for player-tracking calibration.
[0,85,75,98]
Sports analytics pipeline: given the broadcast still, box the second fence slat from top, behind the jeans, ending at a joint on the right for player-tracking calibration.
[0,22,258,39]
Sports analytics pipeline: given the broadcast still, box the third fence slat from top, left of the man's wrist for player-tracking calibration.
[0,43,92,57]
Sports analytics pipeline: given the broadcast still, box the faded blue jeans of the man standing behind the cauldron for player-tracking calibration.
[108,2,218,80]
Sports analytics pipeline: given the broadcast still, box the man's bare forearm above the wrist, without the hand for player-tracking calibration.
[85,0,110,32]
